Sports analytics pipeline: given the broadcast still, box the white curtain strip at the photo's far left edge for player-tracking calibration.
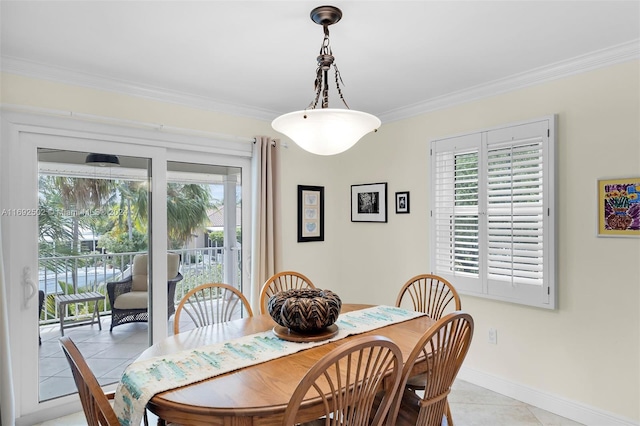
[0,220,15,426]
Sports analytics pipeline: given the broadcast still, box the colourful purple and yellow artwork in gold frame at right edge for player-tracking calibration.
[598,177,640,236]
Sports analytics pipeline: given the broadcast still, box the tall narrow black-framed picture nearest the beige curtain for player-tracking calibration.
[298,185,324,243]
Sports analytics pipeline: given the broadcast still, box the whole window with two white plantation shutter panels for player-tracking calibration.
[430,116,557,309]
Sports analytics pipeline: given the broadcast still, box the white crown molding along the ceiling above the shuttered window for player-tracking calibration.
[379,39,640,122]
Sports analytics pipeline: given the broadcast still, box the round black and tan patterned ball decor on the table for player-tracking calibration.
[268,288,342,333]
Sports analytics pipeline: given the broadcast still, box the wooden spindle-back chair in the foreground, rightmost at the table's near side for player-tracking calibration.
[387,311,473,426]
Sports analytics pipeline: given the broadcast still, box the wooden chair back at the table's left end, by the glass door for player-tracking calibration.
[60,336,120,426]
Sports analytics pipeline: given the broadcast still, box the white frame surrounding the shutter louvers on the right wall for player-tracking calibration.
[429,115,558,309]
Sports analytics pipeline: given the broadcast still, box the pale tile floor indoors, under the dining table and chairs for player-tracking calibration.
[34,380,580,426]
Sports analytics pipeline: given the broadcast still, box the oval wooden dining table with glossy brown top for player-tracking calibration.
[138,304,435,426]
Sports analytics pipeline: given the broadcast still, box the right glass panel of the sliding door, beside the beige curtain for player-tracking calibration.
[167,161,243,330]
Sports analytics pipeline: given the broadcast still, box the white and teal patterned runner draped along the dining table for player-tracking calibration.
[114,306,425,426]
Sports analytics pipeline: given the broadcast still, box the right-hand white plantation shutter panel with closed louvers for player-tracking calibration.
[485,121,552,304]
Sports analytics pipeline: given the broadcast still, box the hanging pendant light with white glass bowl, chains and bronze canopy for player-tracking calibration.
[271,6,381,155]
